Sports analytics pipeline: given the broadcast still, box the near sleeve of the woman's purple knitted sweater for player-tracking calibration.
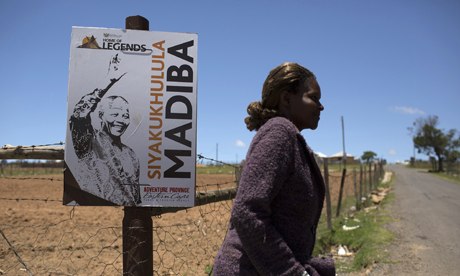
[231,124,307,275]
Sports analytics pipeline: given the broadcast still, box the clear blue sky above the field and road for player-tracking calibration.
[0,0,460,162]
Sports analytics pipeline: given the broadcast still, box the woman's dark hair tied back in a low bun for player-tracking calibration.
[244,62,315,131]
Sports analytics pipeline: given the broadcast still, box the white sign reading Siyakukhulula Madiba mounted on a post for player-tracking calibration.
[64,27,198,207]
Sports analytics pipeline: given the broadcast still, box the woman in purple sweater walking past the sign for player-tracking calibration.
[213,62,335,276]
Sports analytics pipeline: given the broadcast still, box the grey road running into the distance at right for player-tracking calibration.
[371,166,460,275]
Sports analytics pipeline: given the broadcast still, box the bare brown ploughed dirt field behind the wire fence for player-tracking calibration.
[0,172,353,275]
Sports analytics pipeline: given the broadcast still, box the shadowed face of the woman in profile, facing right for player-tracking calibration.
[288,78,324,131]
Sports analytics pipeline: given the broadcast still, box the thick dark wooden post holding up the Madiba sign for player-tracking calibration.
[123,15,153,276]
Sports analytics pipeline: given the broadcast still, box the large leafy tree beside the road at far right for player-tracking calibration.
[409,116,460,171]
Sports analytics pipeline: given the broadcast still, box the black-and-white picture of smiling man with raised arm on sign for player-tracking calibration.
[70,76,141,206]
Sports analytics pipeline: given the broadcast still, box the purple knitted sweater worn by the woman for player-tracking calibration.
[213,117,335,276]
